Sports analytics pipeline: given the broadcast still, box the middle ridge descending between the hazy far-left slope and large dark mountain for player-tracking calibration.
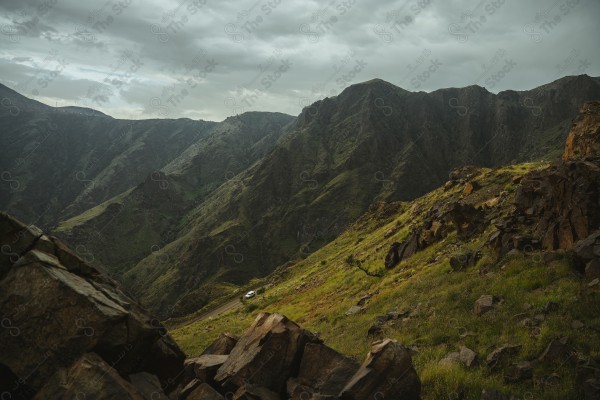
[54,112,293,280]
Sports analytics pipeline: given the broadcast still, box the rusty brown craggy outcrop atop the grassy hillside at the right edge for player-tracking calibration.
[490,101,600,255]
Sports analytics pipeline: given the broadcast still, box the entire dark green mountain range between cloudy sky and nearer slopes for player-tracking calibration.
[0,75,600,318]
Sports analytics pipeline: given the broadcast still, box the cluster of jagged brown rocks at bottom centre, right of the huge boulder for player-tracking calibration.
[178,313,421,400]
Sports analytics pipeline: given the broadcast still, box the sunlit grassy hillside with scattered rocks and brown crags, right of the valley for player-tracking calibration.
[170,102,600,400]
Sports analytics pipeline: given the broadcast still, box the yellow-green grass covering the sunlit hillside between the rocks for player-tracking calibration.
[166,164,600,400]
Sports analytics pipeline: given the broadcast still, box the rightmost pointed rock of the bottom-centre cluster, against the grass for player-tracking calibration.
[340,339,421,400]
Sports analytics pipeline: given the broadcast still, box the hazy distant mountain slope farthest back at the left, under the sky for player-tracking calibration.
[0,81,216,227]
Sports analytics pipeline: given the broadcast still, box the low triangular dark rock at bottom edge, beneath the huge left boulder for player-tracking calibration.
[34,353,145,400]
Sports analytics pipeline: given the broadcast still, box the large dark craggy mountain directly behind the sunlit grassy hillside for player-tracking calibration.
[52,75,600,317]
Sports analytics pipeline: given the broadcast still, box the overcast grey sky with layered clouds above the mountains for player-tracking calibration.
[0,0,600,121]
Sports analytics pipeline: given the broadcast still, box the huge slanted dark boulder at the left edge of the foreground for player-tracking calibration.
[0,213,184,398]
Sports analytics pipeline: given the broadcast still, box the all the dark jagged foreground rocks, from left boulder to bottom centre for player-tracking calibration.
[0,213,420,400]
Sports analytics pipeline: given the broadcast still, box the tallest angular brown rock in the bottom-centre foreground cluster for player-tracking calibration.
[215,313,320,394]
